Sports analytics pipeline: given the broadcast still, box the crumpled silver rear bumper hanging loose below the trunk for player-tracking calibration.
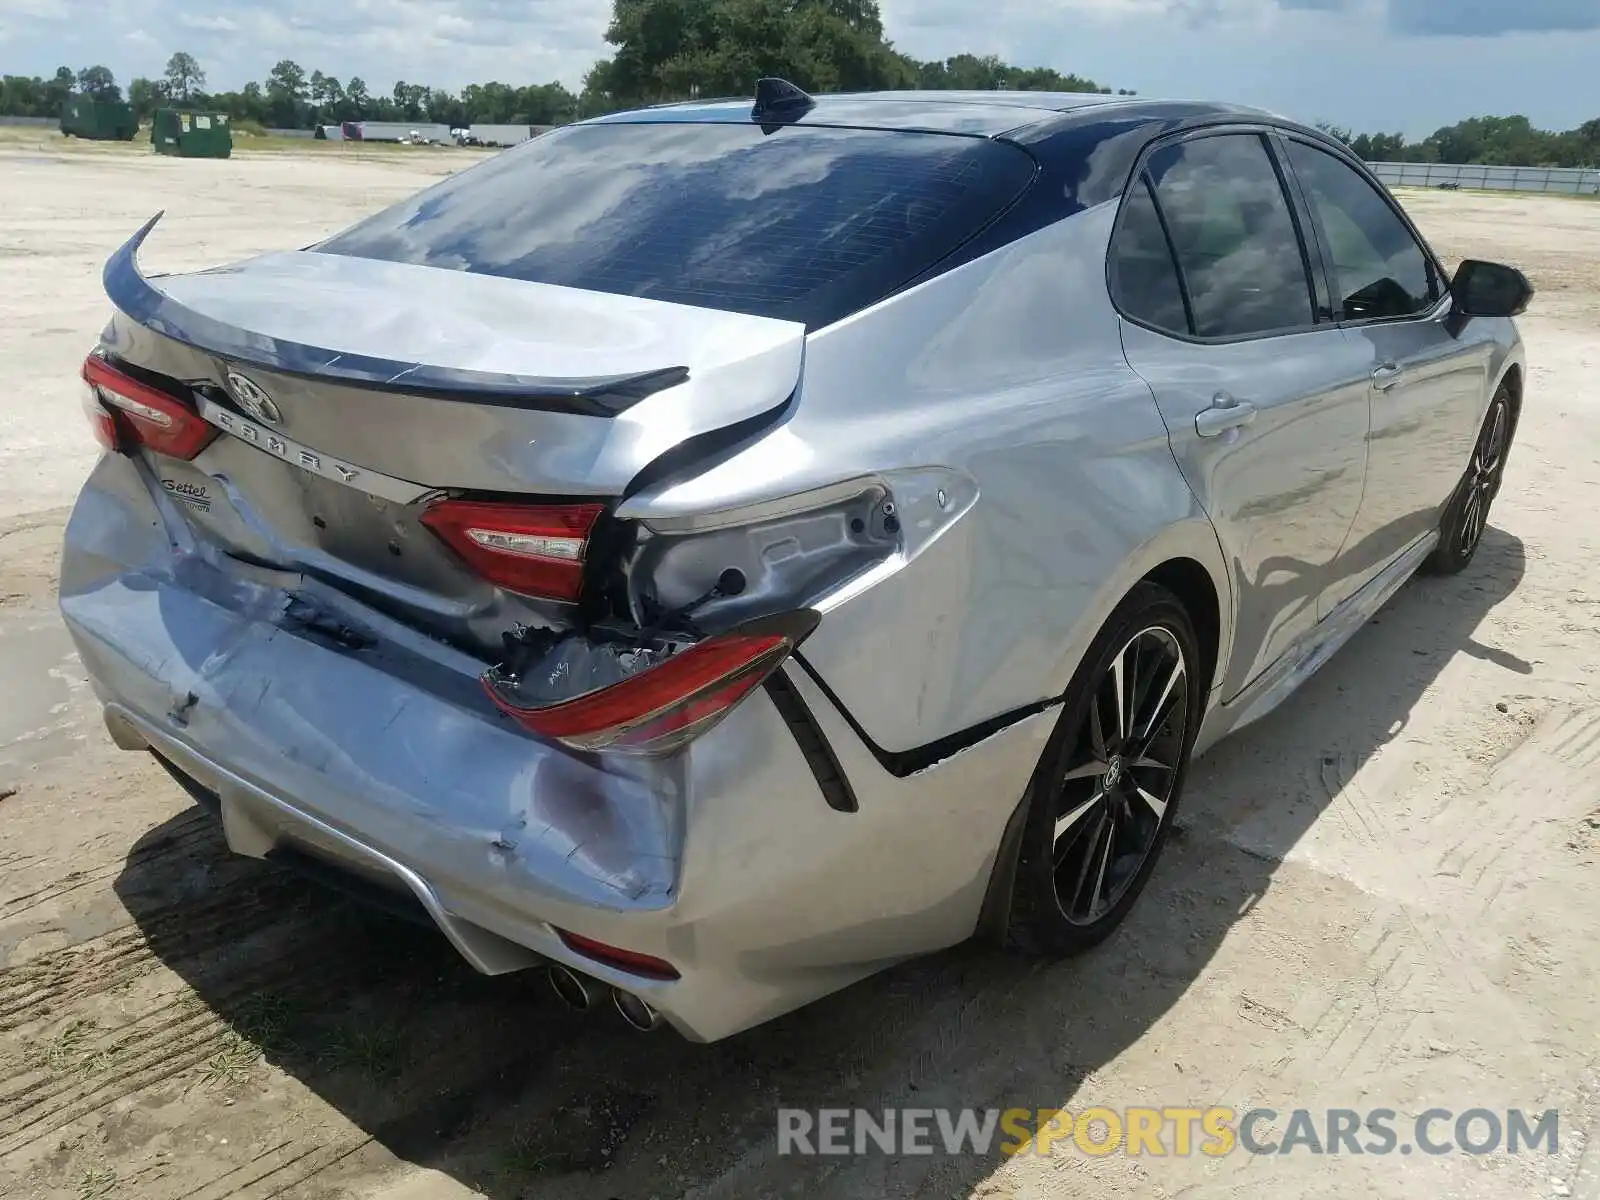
[61,456,1050,1040]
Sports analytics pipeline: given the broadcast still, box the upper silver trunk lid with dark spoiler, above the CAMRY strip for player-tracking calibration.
[106,221,805,496]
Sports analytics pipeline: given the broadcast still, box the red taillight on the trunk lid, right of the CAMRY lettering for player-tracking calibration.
[422,501,605,602]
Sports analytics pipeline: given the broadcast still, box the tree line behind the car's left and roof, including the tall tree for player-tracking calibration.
[0,0,1110,130]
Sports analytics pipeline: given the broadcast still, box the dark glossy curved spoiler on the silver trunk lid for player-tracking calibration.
[102,210,690,416]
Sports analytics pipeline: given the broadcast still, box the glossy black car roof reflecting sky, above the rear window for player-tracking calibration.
[587,91,1283,138]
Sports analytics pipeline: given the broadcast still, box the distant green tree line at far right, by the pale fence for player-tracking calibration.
[1322,117,1600,166]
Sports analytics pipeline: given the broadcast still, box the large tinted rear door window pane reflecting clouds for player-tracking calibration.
[1150,134,1314,338]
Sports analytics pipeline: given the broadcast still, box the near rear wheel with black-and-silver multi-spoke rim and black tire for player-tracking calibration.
[1006,582,1205,957]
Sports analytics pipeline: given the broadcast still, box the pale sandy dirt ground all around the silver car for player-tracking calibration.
[0,133,1600,1200]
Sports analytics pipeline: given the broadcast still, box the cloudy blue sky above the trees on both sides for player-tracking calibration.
[0,0,1600,136]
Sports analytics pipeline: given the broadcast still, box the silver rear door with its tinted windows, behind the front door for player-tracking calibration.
[1110,131,1370,698]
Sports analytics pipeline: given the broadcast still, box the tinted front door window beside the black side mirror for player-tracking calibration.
[1288,142,1440,320]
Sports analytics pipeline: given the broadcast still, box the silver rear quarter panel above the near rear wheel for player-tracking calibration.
[627,203,1229,752]
